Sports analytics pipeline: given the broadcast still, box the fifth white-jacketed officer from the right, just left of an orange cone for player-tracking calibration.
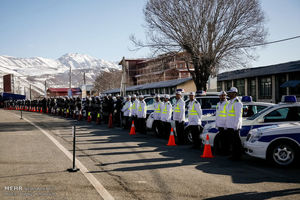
[161,94,172,138]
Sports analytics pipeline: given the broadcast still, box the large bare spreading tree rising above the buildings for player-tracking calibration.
[131,0,267,90]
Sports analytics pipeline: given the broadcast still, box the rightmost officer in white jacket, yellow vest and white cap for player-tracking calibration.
[226,87,243,160]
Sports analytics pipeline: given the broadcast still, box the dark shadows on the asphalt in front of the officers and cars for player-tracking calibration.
[0,111,300,186]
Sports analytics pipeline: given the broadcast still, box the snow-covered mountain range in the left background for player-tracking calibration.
[0,53,121,95]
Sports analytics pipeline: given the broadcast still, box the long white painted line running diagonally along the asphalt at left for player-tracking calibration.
[23,115,114,200]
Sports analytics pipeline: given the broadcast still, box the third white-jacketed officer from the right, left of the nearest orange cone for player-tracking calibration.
[188,92,202,149]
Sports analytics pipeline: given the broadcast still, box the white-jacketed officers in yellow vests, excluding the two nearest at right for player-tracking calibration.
[122,91,202,148]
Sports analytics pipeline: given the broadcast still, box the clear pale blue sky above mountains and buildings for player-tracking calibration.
[0,0,300,66]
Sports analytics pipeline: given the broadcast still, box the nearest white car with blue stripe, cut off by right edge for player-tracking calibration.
[244,122,300,166]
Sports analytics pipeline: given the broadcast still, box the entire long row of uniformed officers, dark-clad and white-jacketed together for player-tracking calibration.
[5,87,243,159]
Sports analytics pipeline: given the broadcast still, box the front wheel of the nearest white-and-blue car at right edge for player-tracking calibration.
[268,142,297,167]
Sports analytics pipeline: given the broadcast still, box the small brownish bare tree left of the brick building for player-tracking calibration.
[94,70,122,93]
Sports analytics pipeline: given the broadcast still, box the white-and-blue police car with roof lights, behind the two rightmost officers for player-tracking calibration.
[200,96,300,151]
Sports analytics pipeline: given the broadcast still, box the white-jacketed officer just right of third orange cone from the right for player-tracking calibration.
[137,95,147,134]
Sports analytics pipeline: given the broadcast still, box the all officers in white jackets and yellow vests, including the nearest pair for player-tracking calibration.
[122,87,243,160]
